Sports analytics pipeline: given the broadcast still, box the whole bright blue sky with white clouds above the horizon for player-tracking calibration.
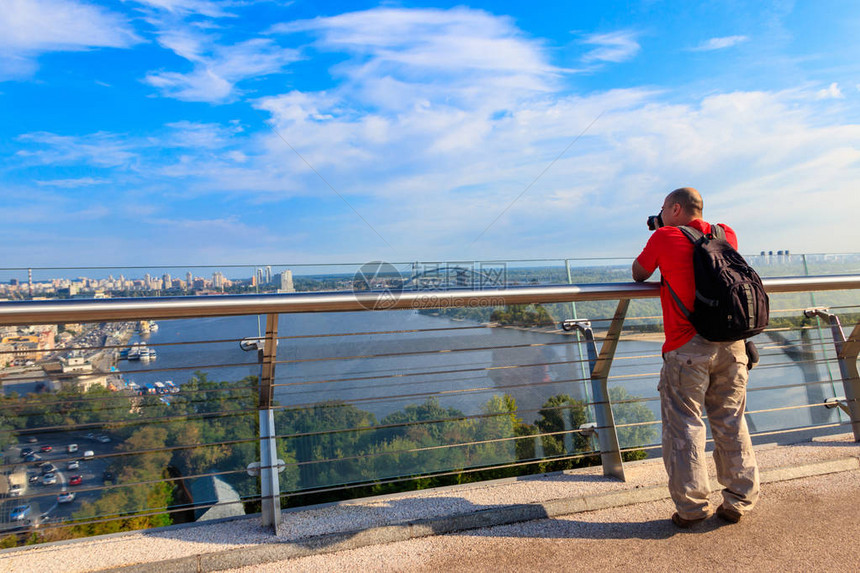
[0,0,860,267]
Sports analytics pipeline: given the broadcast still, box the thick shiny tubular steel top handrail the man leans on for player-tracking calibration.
[0,275,860,326]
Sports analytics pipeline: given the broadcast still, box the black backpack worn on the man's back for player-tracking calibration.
[665,225,770,342]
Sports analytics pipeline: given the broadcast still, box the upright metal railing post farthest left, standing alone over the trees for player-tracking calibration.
[259,314,281,535]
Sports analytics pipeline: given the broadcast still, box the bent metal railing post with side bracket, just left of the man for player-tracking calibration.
[563,299,630,481]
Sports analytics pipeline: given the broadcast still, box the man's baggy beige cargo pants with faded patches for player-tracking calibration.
[658,334,759,519]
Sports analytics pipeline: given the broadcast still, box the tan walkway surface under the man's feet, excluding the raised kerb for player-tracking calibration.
[231,470,860,573]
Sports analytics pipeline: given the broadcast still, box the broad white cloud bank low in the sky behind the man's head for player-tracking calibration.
[249,85,860,258]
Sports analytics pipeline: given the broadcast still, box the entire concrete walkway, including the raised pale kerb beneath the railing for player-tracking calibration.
[0,434,860,573]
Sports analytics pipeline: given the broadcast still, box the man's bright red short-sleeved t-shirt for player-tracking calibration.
[636,219,738,353]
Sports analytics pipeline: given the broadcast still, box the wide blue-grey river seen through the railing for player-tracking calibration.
[112,311,841,438]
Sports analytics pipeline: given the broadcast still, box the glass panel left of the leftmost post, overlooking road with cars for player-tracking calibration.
[0,317,260,540]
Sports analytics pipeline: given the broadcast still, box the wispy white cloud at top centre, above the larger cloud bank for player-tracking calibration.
[273,8,562,108]
